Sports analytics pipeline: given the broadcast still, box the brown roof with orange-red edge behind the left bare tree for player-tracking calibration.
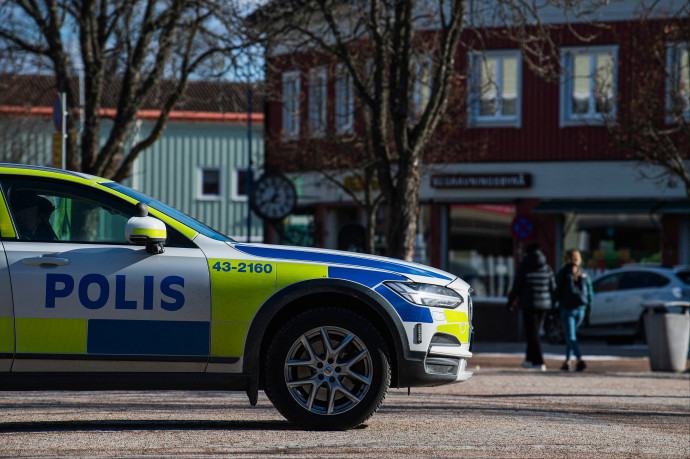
[0,73,264,120]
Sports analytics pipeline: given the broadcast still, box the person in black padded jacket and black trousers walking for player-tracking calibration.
[508,242,556,371]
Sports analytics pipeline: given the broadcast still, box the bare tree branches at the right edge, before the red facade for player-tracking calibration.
[607,1,690,199]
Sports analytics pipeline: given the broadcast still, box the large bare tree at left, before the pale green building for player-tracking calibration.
[0,0,255,180]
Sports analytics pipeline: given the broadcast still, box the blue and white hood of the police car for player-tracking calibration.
[228,243,464,286]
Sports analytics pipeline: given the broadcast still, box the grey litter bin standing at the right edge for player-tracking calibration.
[644,301,690,373]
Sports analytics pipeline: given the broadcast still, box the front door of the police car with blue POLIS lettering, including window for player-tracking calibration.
[2,177,211,372]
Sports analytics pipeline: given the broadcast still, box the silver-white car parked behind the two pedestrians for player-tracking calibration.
[544,265,690,343]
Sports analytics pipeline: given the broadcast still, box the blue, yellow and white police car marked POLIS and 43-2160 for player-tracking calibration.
[0,164,472,429]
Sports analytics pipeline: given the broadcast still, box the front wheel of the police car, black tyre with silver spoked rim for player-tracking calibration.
[265,307,391,430]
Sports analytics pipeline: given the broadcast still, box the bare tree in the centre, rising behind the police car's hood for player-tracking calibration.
[255,0,601,260]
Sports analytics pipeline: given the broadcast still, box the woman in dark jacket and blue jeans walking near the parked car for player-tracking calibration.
[554,249,594,371]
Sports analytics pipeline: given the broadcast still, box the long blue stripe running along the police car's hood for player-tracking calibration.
[233,244,452,281]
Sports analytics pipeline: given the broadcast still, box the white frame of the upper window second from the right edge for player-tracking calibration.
[559,45,618,127]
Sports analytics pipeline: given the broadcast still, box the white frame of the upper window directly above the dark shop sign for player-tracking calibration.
[467,49,522,128]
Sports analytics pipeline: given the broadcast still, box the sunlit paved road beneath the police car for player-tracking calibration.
[0,344,690,458]
